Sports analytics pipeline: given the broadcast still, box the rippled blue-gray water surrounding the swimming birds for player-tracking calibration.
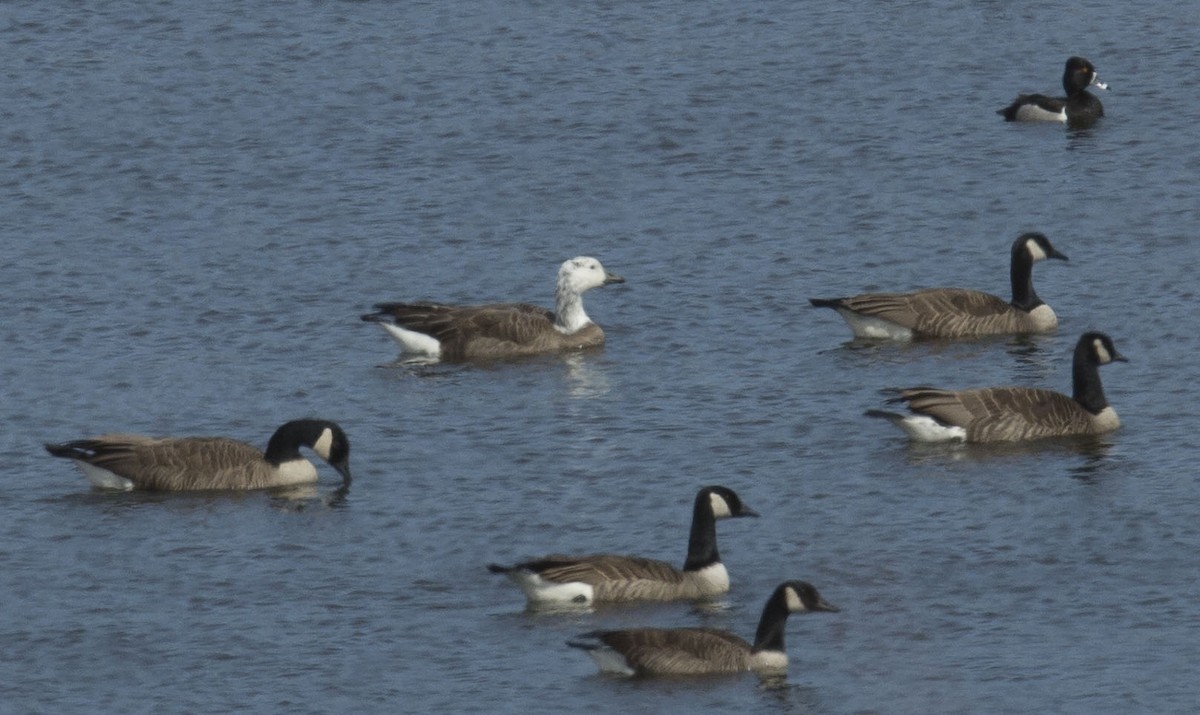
[0,0,1200,713]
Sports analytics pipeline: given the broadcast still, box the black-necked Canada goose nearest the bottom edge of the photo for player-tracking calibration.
[566,581,838,675]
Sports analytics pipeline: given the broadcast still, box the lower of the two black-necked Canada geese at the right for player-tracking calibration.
[866,332,1126,441]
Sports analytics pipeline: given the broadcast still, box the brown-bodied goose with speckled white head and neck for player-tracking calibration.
[362,257,625,361]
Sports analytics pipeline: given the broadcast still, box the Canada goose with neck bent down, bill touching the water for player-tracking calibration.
[46,420,350,492]
